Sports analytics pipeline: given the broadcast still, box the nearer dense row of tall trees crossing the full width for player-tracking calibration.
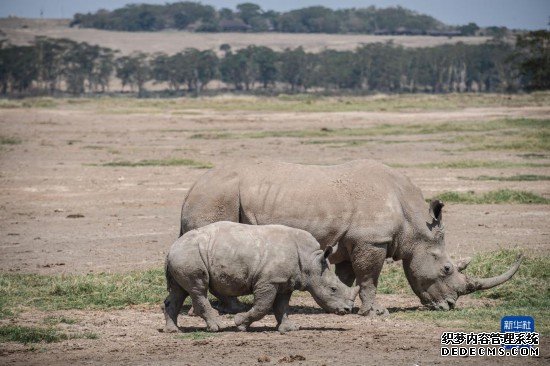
[0,31,550,96]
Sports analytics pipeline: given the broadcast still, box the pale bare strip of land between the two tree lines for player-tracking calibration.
[0,18,489,54]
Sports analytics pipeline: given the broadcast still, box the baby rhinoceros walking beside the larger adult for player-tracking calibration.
[164,222,359,333]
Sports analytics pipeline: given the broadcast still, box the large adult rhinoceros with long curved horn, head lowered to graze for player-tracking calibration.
[181,160,521,315]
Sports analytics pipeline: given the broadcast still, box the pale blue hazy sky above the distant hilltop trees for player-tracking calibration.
[0,0,550,29]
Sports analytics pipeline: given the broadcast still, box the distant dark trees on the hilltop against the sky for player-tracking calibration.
[71,1,506,36]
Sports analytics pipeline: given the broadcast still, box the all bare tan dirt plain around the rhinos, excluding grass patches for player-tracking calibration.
[0,98,550,365]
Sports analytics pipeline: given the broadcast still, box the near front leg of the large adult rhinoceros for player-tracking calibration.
[351,244,389,316]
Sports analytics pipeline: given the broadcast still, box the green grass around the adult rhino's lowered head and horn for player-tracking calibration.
[378,250,550,335]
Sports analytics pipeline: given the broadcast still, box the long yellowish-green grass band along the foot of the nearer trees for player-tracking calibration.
[0,92,550,114]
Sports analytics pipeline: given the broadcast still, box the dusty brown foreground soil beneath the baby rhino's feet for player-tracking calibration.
[0,295,550,366]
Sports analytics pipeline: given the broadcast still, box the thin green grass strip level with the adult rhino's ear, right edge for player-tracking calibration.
[435,189,550,204]
